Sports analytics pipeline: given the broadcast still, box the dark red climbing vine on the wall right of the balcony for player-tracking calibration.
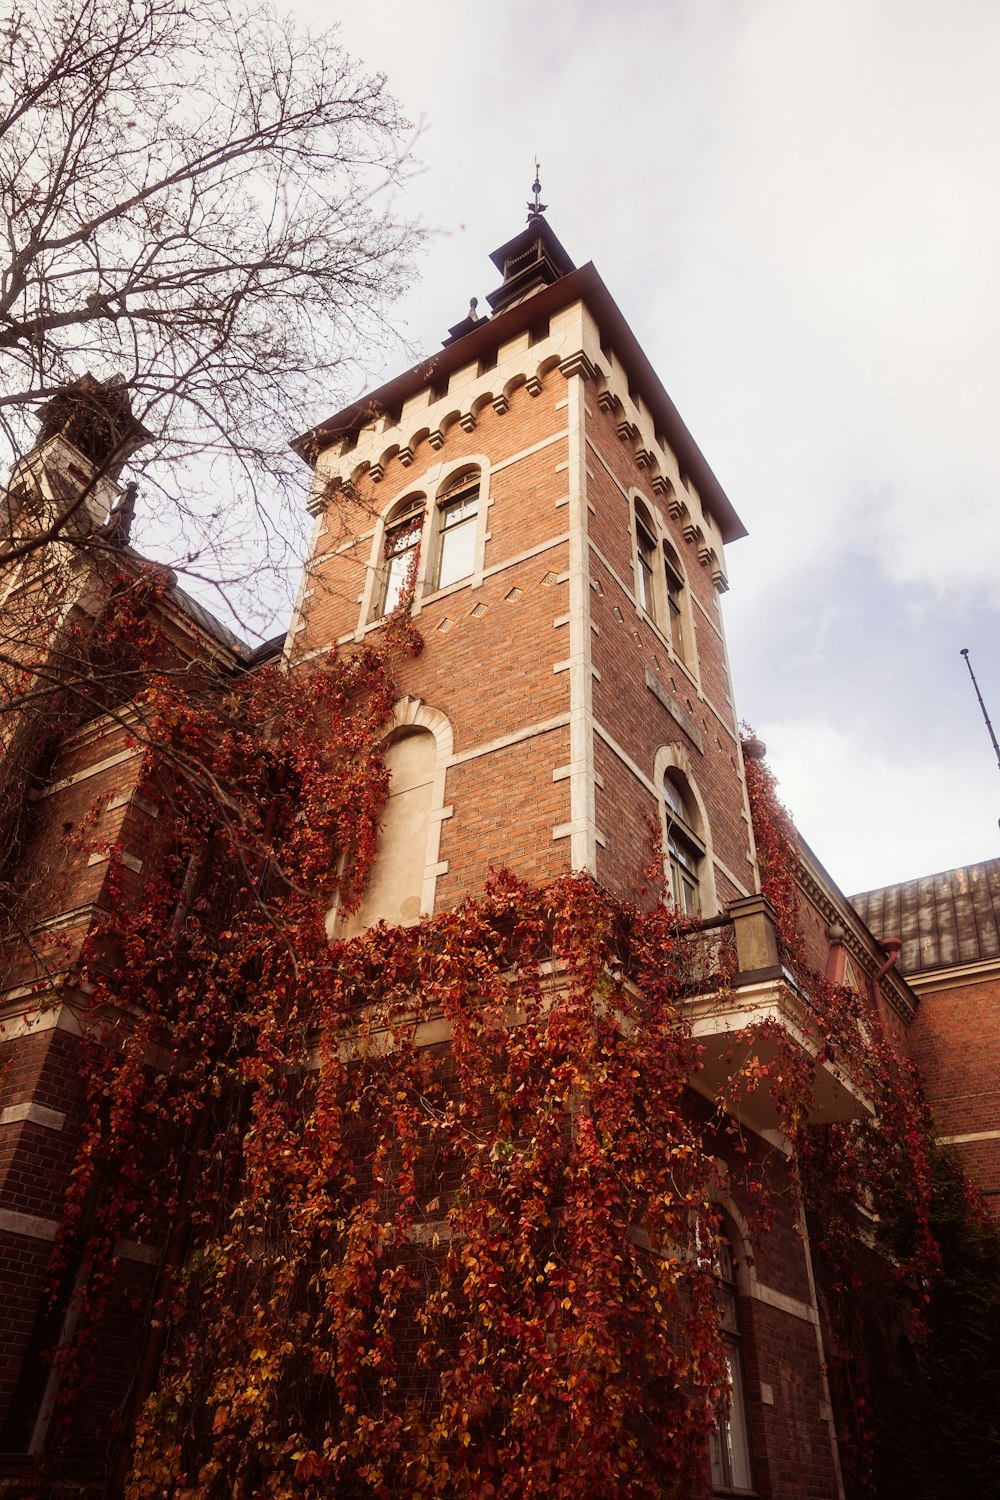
[745,732,940,1497]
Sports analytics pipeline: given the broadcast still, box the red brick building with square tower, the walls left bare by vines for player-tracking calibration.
[0,213,953,1500]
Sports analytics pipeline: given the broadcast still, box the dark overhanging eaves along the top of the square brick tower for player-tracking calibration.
[289,261,747,543]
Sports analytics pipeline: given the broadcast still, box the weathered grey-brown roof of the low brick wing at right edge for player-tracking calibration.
[850,860,1000,974]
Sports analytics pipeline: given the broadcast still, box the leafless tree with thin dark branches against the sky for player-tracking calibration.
[0,0,412,615]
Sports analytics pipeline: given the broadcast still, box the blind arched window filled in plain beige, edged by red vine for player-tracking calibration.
[339,728,438,938]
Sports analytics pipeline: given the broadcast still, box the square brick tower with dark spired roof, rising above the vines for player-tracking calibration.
[288,206,756,930]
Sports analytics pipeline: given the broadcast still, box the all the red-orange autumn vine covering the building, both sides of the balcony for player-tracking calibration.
[19,588,989,1500]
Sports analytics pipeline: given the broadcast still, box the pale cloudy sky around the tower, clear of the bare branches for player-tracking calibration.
[288,0,1000,893]
